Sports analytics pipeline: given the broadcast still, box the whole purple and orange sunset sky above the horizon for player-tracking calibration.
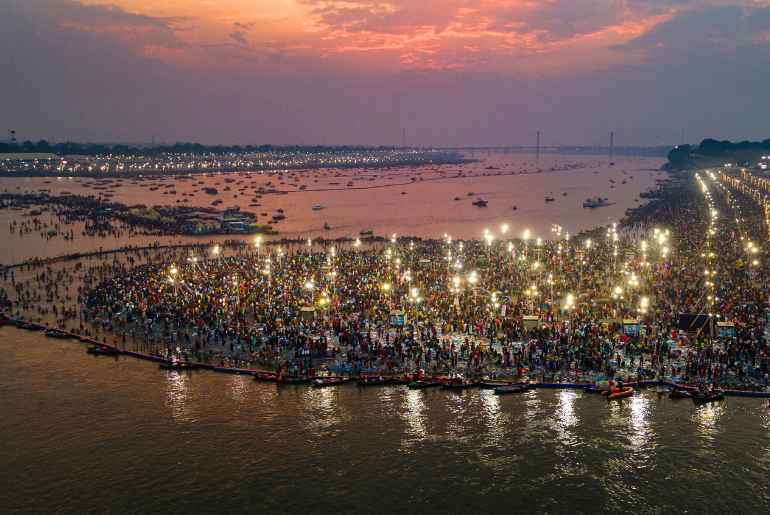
[0,0,770,145]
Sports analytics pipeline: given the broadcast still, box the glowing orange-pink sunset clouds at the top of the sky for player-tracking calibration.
[70,0,700,75]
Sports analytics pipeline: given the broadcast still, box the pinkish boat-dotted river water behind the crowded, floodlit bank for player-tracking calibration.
[0,153,665,263]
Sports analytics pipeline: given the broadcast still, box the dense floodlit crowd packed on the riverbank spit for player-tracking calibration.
[0,169,770,388]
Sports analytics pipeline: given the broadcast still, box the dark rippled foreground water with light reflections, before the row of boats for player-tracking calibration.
[0,327,770,513]
